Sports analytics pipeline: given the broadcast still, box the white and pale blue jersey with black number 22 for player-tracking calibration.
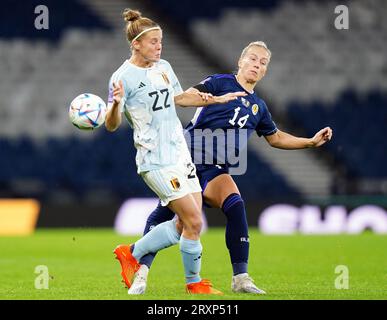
[108,60,189,173]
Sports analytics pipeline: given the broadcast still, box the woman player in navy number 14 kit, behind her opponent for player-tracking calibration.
[129,41,332,294]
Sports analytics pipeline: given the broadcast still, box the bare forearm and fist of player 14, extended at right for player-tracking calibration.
[265,127,332,150]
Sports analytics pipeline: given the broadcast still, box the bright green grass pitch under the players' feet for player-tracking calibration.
[0,228,387,300]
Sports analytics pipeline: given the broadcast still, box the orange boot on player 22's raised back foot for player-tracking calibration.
[113,244,141,289]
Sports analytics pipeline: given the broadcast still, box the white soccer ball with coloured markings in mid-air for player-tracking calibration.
[69,93,107,130]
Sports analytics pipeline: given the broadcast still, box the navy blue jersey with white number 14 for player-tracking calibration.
[185,74,277,165]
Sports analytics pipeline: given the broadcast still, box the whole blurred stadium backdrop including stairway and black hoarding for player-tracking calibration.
[0,0,387,232]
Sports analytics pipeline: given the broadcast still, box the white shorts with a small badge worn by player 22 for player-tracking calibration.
[140,159,202,207]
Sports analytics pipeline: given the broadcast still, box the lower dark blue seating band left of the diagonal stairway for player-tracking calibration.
[0,128,297,199]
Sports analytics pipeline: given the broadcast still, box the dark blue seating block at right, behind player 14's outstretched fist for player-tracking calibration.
[288,90,387,178]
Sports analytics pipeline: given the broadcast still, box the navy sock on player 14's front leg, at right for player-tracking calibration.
[222,193,249,275]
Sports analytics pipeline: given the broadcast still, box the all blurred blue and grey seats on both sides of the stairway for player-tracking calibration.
[0,0,387,199]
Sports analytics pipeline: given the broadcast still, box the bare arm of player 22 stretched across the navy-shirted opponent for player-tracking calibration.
[175,88,247,107]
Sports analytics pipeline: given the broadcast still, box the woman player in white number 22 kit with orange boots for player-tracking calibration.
[105,9,245,294]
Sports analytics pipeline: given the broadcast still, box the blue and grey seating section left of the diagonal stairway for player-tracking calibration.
[0,0,304,201]
